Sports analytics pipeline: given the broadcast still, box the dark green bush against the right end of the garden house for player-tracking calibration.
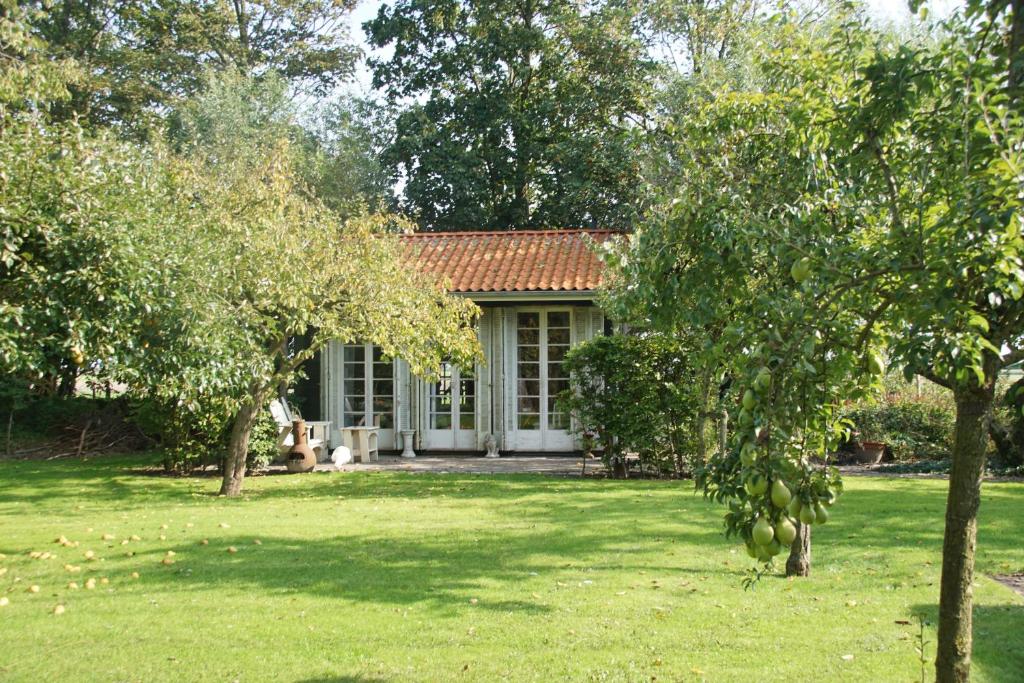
[559,334,700,475]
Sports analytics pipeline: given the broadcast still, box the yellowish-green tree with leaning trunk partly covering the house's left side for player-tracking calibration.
[134,92,478,496]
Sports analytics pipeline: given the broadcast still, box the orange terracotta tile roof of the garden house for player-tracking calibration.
[402,230,618,293]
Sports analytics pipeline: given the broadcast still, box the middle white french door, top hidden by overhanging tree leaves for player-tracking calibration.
[424,362,476,450]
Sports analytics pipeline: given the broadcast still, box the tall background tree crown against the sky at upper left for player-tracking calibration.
[25,0,358,135]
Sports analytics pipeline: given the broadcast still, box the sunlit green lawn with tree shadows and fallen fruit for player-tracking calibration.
[0,457,1024,681]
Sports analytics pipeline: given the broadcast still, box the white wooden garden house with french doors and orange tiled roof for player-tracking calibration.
[307,230,615,454]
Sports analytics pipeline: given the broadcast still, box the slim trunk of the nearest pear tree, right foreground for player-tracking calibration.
[935,374,998,683]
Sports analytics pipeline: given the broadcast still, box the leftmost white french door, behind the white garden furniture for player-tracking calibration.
[341,344,395,449]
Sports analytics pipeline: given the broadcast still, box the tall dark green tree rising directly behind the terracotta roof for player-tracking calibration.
[366,0,652,230]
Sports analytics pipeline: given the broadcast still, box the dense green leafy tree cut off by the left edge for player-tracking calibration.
[0,6,178,395]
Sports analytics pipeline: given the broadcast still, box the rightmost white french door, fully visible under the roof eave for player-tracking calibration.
[515,309,573,451]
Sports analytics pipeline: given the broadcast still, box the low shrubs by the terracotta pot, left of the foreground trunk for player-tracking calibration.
[844,400,953,461]
